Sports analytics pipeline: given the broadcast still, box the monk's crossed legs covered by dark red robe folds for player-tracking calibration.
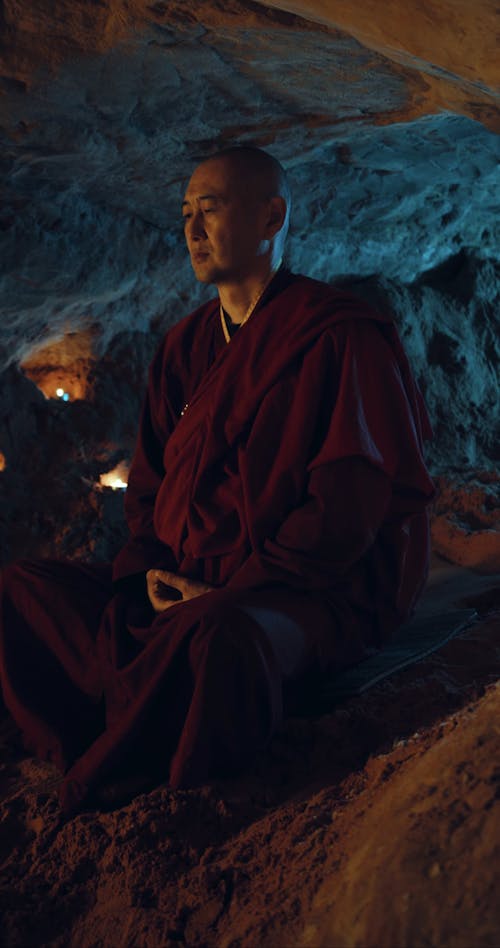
[0,561,346,802]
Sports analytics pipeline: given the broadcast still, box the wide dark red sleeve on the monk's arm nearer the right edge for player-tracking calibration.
[229,320,433,590]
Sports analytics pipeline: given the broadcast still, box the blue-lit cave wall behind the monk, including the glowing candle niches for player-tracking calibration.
[0,0,500,561]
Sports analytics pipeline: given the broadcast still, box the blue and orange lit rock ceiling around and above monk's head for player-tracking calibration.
[0,0,499,365]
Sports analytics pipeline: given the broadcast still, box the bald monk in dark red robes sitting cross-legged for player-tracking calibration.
[0,147,433,812]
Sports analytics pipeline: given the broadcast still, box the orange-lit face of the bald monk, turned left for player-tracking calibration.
[182,158,267,284]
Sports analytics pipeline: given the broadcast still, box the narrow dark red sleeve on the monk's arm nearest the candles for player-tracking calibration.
[113,341,177,586]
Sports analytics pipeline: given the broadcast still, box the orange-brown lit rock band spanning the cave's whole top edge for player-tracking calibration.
[0,0,499,128]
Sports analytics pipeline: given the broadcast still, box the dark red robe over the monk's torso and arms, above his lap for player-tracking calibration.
[114,273,433,643]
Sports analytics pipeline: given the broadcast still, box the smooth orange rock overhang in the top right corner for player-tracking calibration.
[266,0,500,130]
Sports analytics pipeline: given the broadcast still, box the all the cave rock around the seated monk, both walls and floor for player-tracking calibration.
[0,0,500,948]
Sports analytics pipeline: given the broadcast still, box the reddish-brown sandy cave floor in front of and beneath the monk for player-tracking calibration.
[0,558,500,948]
